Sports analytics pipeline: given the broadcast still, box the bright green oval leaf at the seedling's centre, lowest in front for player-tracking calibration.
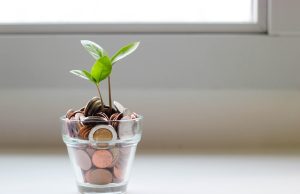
[91,56,112,84]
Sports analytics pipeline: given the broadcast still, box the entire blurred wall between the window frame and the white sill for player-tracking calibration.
[0,34,300,148]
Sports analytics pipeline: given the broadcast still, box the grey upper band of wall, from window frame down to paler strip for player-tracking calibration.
[0,34,300,89]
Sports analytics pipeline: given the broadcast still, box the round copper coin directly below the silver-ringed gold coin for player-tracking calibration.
[92,150,113,168]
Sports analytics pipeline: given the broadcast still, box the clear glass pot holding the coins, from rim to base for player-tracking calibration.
[61,115,143,194]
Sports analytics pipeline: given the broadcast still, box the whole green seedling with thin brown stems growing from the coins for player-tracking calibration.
[70,40,139,112]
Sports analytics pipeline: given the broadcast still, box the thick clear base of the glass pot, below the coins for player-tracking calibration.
[77,183,127,194]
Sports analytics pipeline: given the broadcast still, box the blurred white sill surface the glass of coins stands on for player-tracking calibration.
[0,150,300,194]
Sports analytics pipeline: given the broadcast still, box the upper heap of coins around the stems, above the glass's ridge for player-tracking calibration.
[66,97,139,141]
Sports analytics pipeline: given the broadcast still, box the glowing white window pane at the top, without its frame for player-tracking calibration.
[0,0,257,24]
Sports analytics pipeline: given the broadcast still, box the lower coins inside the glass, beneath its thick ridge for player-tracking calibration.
[70,146,132,185]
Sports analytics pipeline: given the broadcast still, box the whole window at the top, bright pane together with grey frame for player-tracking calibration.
[0,0,266,32]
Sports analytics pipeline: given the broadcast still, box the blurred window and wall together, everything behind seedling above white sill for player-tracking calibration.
[0,0,300,191]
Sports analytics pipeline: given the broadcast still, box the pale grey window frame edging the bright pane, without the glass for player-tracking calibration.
[0,0,268,34]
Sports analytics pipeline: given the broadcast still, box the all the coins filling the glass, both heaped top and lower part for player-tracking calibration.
[65,97,139,185]
